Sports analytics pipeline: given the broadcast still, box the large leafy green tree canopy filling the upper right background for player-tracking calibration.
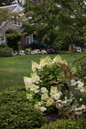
[24,0,86,49]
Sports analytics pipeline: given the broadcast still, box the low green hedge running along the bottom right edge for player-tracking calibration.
[40,119,86,129]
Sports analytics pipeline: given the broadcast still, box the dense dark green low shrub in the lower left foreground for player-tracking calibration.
[0,88,45,129]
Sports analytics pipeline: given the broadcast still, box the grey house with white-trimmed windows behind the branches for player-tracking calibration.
[0,4,33,44]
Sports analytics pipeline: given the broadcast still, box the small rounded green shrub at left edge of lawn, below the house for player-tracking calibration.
[0,47,13,57]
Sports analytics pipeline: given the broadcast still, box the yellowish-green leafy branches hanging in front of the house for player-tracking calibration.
[0,7,25,43]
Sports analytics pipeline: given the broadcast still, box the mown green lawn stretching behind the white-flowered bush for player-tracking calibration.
[0,53,85,90]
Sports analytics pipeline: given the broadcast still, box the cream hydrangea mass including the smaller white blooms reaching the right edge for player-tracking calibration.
[24,55,86,115]
